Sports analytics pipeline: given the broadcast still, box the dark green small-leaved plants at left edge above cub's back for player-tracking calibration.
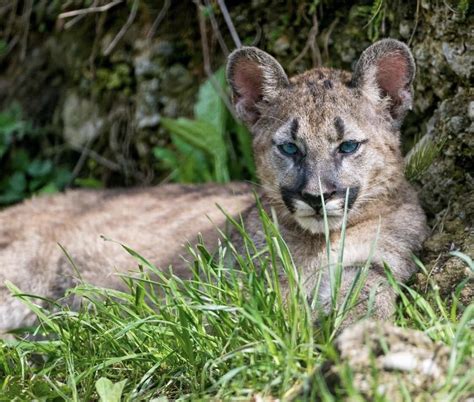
[0,105,71,205]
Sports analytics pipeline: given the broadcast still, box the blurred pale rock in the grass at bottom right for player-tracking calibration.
[326,320,450,401]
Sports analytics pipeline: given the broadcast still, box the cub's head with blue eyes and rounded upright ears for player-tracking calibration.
[227,39,415,233]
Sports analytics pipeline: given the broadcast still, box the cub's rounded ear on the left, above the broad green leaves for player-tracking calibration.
[227,47,289,125]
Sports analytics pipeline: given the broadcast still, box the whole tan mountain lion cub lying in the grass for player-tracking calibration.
[0,39,426,331]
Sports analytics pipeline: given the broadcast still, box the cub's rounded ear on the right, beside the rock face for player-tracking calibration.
[353,39,415,126]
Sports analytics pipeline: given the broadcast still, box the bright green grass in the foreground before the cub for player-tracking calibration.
[0,203,474,401]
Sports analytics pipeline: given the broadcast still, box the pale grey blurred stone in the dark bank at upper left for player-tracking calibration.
[61,91,105,146]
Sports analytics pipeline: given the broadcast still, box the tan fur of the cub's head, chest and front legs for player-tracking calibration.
[228,39,426,319]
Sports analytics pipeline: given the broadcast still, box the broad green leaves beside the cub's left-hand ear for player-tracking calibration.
[153,68,255,183]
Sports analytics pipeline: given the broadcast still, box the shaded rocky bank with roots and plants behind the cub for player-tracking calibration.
[0,0,474,302]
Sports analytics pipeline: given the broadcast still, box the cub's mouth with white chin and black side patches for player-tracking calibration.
[281,187,359,233]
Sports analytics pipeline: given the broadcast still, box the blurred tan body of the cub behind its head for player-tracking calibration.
[0,183,254,332]
